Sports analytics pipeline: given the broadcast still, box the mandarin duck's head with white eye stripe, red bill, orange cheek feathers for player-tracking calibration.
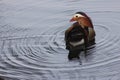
[70,12,93,28]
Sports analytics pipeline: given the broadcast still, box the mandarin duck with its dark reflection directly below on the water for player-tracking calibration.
[65,12,96,60]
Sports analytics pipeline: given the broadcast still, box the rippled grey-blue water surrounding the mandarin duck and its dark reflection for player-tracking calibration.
[0,0,120,80]
